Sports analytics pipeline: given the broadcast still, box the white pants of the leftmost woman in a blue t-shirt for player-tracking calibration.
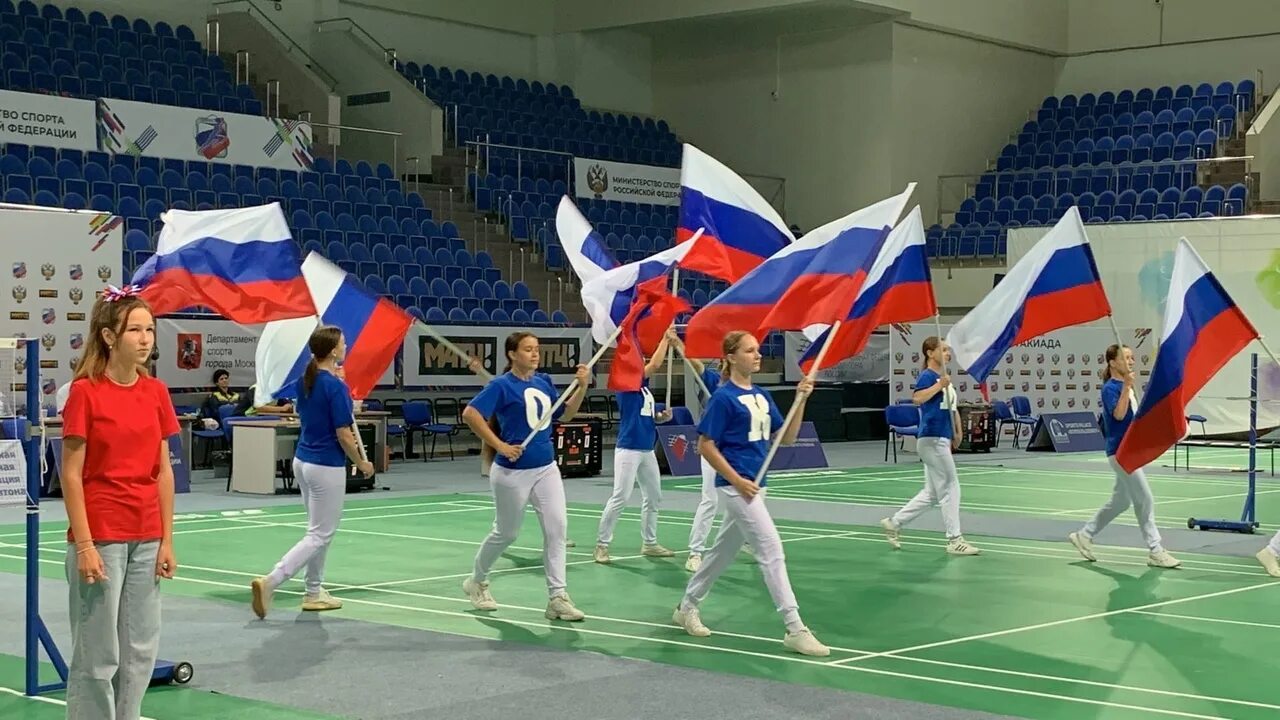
[266,457,347,594]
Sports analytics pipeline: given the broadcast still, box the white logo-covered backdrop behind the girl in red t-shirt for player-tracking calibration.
[0,208,124,414]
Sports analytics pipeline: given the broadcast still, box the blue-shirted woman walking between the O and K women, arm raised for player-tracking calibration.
[593,329,676,564]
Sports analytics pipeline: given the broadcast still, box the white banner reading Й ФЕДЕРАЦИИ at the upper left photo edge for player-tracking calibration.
[0,90,97,150]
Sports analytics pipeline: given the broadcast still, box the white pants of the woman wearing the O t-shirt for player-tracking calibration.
[472,462,568,597]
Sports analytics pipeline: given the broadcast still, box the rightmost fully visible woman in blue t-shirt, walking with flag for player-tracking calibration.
[1068,345,1181,568]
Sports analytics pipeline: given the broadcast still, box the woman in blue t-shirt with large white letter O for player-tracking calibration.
[462,332,590,620]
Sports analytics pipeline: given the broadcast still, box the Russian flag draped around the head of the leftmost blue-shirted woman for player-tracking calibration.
[255,252,413,404]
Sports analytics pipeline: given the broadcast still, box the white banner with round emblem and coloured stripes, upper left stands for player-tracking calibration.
[97,99,315,170]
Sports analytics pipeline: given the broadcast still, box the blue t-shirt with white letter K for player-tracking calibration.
[698,382,783,487]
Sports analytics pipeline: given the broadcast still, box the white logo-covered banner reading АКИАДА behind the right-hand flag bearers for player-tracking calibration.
[890,323,1157,437]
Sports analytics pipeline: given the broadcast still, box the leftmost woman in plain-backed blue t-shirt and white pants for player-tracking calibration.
[250,327,374,618]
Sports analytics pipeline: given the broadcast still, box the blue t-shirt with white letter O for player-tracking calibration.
[467,373,564,470]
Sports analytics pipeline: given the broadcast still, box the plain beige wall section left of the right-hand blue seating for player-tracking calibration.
[892,24,1053,225]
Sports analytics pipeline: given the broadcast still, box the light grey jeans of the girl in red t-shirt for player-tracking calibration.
[65,539,160,720]
